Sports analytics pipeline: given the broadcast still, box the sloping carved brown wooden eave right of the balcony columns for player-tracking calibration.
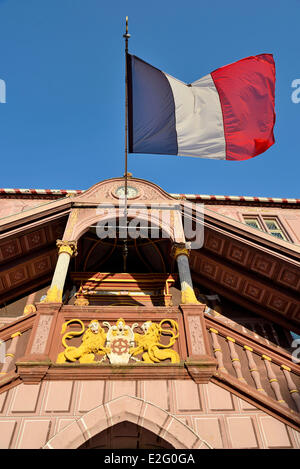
[180,206,300,333]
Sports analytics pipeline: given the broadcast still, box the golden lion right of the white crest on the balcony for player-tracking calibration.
[130,319,180,363]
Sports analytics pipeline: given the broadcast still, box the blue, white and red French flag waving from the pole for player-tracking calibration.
[127,54,275,160]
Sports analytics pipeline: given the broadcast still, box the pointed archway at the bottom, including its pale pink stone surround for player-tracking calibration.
[44,395,212,449]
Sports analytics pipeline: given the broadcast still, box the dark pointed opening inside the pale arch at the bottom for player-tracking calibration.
[78,421,174,449]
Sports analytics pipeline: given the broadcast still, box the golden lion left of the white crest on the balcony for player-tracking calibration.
[56,319,110,363]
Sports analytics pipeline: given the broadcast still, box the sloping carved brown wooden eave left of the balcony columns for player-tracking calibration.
[0,200,71,304]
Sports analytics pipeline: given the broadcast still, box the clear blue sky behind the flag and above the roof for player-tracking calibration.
[0,0,300,198]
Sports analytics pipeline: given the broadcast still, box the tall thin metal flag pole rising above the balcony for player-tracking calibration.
[123,16,130,272]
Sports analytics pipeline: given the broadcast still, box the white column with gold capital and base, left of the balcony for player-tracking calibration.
[44,239,77,303]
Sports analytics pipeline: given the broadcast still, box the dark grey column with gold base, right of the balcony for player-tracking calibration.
[172,244,199,304]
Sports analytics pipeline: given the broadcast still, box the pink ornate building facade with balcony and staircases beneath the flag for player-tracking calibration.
[0,176,300,449]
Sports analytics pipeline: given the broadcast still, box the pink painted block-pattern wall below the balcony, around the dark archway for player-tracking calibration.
[0,380,300,449]
